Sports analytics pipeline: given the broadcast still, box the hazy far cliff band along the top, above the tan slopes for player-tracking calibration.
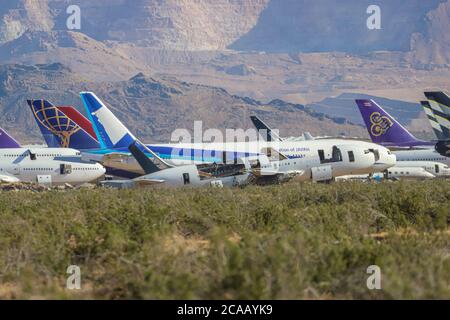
[0,0,450,57]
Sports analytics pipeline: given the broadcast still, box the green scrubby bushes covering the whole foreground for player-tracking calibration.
[0,181,450,299]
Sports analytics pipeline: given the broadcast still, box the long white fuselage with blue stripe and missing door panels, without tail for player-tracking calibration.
[100,139,396,178]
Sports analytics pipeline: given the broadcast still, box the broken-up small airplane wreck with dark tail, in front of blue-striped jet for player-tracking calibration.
[103,141,384,187]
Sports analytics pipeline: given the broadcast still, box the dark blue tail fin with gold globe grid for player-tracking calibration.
[27,100,99,150]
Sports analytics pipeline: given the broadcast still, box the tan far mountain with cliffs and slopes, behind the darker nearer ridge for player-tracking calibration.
[0,0,450,130]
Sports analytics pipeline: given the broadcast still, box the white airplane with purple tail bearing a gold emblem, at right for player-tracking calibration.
[356,100,450,165]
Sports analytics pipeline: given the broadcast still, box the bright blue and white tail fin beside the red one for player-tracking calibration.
[80,92,136,148]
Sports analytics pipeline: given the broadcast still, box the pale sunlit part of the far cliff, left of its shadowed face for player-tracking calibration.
[0,0,269,50]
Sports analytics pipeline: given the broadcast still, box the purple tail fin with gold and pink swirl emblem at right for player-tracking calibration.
[356,100,419,145]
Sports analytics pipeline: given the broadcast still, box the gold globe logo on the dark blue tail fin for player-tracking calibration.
[31,100,81,148]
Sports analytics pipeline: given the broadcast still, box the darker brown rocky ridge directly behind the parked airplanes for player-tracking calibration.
[0,64,365,142]
